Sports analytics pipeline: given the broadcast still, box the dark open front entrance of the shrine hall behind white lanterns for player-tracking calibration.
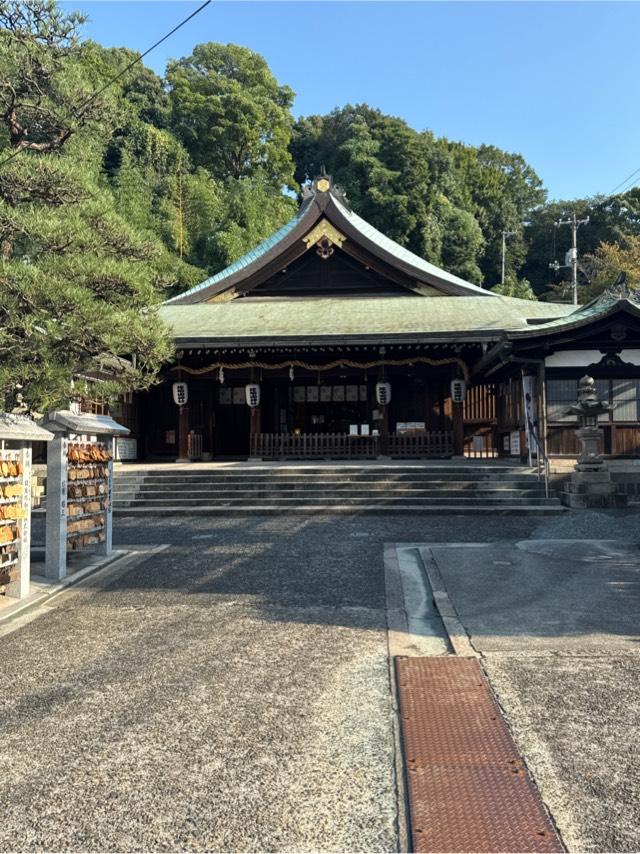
[141,364,462,461]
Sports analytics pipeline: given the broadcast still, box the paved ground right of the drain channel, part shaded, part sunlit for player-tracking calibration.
[424,528,640,852]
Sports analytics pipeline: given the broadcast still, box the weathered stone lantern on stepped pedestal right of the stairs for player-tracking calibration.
[562,376,627,507]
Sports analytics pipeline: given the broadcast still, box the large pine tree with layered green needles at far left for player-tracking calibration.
[0,0,182,410]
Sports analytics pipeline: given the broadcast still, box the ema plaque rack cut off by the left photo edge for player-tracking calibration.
[0,413,53,599]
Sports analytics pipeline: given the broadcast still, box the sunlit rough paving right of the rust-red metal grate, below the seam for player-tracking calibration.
[483,653,640,852]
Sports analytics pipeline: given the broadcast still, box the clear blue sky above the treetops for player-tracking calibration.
[63,0,640,198]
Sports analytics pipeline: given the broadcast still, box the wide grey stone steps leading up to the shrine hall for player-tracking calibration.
[113,462,564,516]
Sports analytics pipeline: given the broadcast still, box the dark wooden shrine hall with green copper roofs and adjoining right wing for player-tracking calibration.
[117,176,640,461]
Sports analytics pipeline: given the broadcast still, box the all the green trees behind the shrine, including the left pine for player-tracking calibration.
[0,0,640,407]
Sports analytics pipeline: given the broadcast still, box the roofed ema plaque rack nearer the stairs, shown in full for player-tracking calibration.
[45,410,129,579]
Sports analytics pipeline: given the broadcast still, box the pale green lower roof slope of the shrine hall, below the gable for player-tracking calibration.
[160,295,573,346]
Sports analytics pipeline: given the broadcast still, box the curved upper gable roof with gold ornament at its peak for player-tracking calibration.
[167,177,497,305]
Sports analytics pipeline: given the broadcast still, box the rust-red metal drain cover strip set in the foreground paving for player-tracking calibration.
[396,657,564,852]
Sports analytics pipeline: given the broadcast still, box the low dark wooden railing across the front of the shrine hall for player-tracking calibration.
[251,431,453,460]
